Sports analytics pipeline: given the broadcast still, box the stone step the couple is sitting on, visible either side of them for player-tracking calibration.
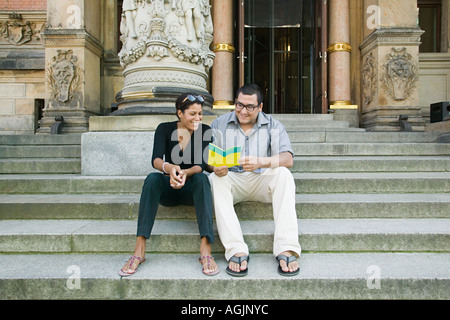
[0,172,450,194]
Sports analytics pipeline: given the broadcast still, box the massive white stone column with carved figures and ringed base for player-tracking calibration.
[113,0,214,115]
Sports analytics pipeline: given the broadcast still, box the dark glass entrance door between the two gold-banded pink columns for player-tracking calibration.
[238,0,321,113]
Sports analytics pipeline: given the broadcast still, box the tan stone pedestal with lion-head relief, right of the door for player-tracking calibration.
[361,28,425,131]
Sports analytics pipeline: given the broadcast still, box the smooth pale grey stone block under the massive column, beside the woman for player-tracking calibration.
[81,114,216,176]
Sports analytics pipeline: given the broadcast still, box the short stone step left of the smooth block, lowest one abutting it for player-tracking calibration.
[0,157,81,174]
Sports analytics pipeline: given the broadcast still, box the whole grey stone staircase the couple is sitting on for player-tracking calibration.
[0,115,450,300]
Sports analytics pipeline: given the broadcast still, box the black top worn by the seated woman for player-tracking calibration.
[152,121,212,169]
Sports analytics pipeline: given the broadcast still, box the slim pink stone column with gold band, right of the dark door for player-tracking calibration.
[328,0,359,126]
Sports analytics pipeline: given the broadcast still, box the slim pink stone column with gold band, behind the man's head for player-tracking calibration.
[212,0,235,109]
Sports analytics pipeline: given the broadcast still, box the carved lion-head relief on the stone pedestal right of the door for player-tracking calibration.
[383,47,418,101]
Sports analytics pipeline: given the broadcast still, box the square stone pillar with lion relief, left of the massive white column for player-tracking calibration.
[38,0,103,133]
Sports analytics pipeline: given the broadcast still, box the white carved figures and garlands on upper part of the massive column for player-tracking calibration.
[119,0,214,70]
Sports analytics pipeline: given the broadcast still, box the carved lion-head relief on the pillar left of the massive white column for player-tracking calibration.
[47,50,82,108]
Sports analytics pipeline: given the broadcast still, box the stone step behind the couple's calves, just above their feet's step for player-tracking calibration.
[0,219,450,253]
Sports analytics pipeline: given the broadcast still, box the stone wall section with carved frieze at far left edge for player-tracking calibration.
[0,9,46,134]
